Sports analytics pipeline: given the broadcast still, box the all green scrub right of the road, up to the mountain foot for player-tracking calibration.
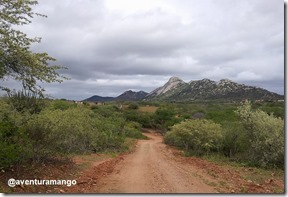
[124,101,284,168]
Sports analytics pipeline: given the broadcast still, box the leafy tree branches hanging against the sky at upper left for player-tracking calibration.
[0,0,66,94]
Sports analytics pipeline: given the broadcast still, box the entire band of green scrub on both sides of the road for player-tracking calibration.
[0,94,284,168]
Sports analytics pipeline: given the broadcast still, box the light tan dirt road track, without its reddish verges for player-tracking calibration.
[95,133,217,193]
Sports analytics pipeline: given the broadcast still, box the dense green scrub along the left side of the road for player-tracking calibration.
[0,91,145,168]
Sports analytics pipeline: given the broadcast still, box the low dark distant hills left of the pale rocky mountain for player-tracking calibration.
[83,90,148,102]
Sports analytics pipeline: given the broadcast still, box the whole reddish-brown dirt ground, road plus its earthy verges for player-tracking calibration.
[0,133,285,194]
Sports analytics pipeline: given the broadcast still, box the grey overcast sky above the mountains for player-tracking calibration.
[1,0,284,100]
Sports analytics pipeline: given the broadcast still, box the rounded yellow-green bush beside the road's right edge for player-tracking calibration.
[164,119,222,155]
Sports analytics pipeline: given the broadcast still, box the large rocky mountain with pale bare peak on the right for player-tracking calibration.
[145,77,284,101]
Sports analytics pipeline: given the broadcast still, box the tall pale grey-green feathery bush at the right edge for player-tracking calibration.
[236,102,284,167]
